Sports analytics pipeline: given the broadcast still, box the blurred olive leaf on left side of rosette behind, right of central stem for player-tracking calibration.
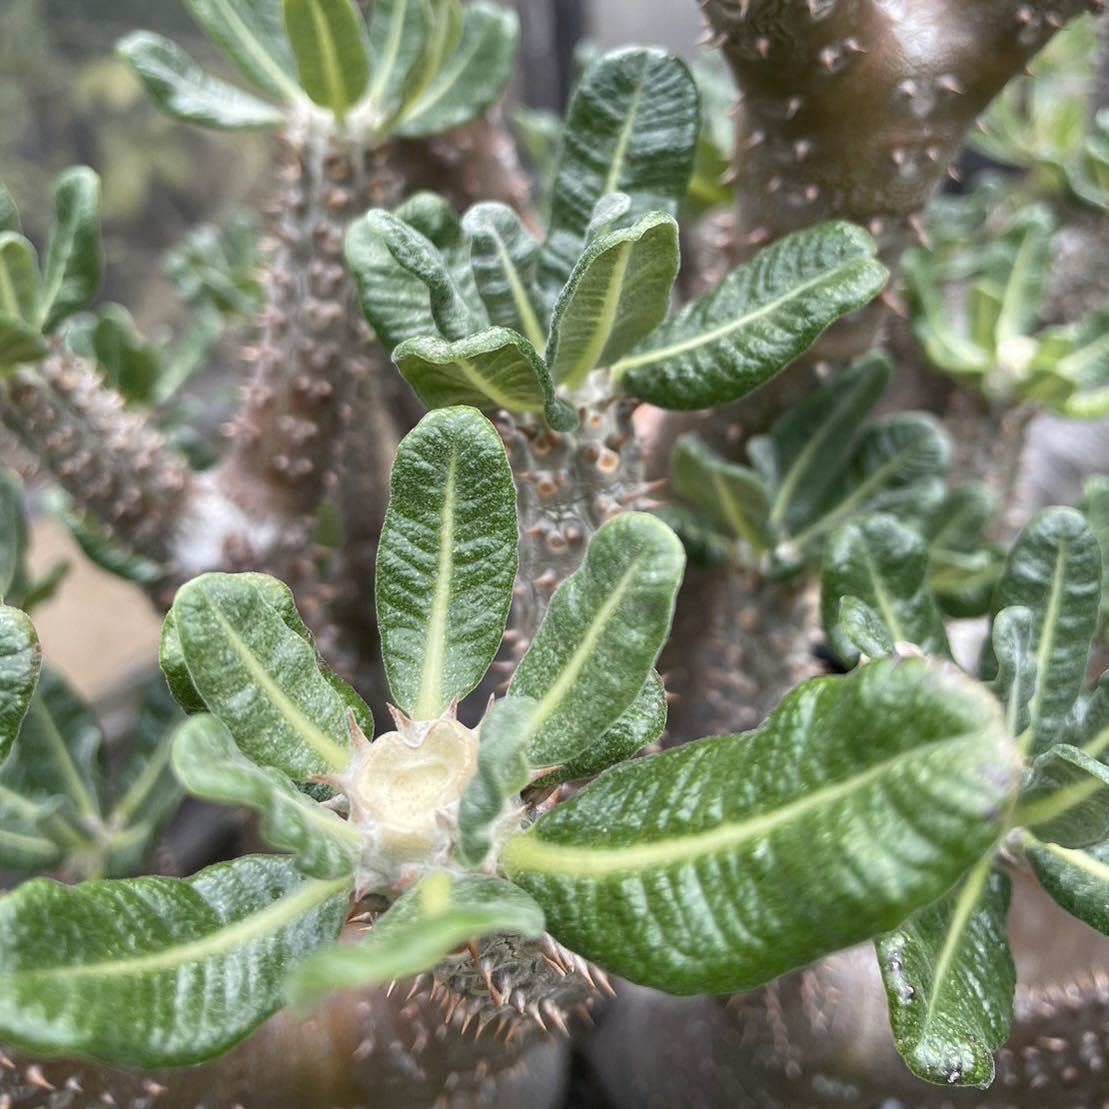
[672,435,769,553]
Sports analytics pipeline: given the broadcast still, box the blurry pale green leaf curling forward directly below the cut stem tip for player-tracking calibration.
[288,871,543,1013]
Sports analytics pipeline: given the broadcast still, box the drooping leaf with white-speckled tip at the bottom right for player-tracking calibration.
[876,858,1017,1089]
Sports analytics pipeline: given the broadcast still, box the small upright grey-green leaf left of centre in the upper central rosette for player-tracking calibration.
[462,204,547,350]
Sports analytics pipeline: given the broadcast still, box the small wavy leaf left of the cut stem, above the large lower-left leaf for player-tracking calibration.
[173,715,362,878]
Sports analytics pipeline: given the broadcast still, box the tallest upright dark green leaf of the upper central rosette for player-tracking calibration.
[540,49,699,302]
